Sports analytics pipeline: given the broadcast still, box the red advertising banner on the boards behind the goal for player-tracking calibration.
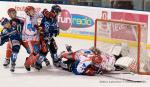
[111,12,148,41]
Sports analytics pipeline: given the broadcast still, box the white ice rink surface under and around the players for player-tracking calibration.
[0,37,150,87]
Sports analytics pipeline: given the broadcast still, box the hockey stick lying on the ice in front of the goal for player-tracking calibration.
[102,74,145,83]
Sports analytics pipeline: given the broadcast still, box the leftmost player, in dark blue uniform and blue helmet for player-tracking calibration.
[0,18,21,72]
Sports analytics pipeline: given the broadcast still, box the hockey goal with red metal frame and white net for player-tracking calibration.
[94,19,150,74]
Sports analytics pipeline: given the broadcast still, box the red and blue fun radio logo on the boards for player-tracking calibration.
[58,10,94,30]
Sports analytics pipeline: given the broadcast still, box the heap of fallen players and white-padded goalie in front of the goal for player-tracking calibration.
[59,45,137,75]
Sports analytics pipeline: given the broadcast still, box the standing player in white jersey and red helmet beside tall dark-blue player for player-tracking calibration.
[22,6,47,71]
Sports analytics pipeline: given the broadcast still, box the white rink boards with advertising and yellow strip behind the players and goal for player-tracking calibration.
[0,1,150,43]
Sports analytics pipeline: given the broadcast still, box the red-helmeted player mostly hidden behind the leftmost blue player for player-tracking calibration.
[3,8,24,66]
